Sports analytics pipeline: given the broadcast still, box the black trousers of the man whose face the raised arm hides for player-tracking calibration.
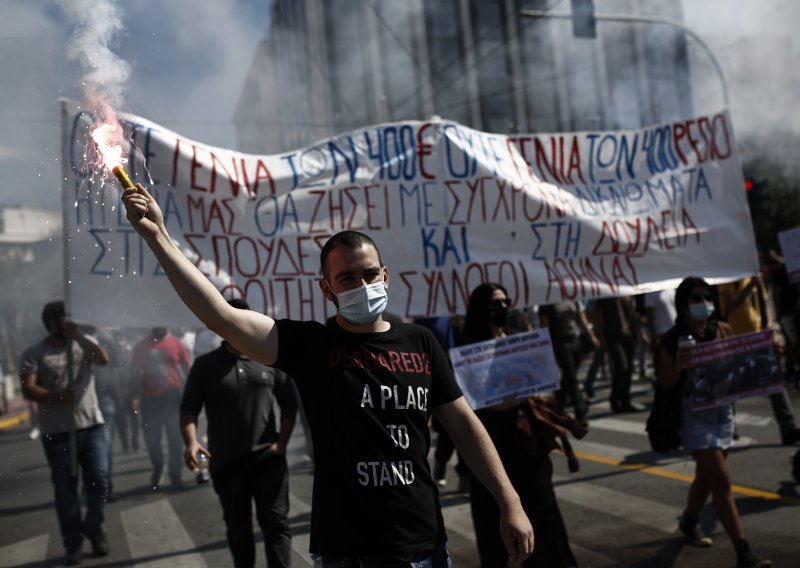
[211,451,292,568]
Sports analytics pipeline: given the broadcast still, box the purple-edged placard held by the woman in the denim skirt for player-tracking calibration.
[687,330,784,410]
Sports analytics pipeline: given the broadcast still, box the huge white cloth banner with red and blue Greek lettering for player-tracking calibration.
[63,101,758,326]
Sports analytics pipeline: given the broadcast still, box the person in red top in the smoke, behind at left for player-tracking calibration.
[131,327,191,489]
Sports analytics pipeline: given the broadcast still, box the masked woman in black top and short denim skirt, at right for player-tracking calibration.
[661,277,772,568]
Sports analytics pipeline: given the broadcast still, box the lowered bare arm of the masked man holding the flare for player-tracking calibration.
[434,396,534,565]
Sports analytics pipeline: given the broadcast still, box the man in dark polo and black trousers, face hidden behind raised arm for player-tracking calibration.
[180,300,297,568]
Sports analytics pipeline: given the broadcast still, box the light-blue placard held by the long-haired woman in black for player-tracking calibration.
[449,329,558,410]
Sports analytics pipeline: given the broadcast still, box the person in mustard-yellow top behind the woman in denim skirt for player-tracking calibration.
[717,275,800,446]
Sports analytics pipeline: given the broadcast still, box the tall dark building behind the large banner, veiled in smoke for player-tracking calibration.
[234,0,692,153]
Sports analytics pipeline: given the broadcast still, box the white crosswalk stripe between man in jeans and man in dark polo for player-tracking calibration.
[120,499,207,568]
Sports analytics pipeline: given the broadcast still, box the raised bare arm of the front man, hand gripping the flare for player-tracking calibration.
[122,183,278,365]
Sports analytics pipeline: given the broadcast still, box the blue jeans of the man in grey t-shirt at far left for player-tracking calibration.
[42,426,108,548]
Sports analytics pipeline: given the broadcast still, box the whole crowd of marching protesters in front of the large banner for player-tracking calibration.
[15,180,800,568]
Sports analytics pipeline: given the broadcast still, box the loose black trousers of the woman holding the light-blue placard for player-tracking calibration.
[470,449,577,568]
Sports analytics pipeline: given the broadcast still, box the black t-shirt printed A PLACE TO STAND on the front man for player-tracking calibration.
[275,320,461,557]
